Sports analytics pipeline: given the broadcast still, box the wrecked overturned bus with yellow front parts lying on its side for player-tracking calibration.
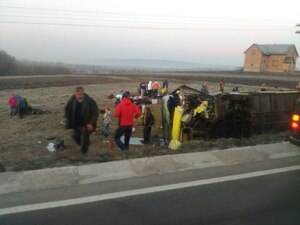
[162,85,300,147]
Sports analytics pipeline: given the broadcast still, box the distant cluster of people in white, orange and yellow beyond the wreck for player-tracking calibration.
[139,80,169,99]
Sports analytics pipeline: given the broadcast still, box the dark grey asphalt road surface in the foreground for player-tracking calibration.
[0,157,300,225]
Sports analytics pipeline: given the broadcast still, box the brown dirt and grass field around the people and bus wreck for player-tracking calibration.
[0,74,295,172]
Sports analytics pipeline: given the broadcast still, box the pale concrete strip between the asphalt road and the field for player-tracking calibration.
[0,142,300,194]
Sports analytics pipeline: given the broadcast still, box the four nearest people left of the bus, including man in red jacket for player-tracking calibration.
[65,86,154,154]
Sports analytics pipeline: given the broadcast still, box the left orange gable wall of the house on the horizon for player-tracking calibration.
[244,45,263,72]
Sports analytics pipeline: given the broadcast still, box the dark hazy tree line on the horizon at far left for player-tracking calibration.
[0,50,71,76]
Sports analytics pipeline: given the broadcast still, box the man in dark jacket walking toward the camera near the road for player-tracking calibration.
[65,86,99,154]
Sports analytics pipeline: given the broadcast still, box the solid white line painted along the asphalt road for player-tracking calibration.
[0,165,300,216]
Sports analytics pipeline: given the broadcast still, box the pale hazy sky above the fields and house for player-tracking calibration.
[0,0,300,68]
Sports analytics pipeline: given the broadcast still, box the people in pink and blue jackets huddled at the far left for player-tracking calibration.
[7,93,32,118]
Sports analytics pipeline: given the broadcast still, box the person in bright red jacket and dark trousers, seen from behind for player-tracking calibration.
[114,91,141,151]
